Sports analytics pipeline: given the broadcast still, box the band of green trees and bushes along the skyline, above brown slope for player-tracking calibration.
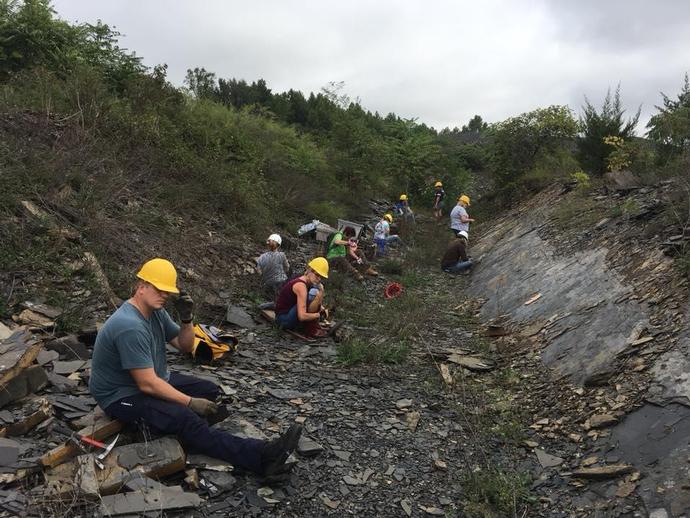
[0,0,690,230]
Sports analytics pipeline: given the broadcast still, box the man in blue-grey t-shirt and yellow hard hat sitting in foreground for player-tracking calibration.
[89,258,302,476]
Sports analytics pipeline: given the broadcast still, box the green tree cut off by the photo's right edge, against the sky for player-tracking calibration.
[647,73,690,159]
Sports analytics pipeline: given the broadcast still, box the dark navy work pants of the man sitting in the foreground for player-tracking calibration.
[105,372,264,473]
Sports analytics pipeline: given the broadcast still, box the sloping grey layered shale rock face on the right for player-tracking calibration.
[468,182,690,516]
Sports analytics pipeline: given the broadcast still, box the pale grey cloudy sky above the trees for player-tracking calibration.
[53,0,690,129]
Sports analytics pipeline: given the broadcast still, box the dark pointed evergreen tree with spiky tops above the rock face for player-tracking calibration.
[577,85,640,175]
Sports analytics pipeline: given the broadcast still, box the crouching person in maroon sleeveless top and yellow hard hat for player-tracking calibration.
[275,257,328,337]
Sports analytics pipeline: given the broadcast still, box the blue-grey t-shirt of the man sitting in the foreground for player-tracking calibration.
[89,302,180,410]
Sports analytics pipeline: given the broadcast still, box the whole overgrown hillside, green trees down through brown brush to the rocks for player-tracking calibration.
[0,0,690,316]
